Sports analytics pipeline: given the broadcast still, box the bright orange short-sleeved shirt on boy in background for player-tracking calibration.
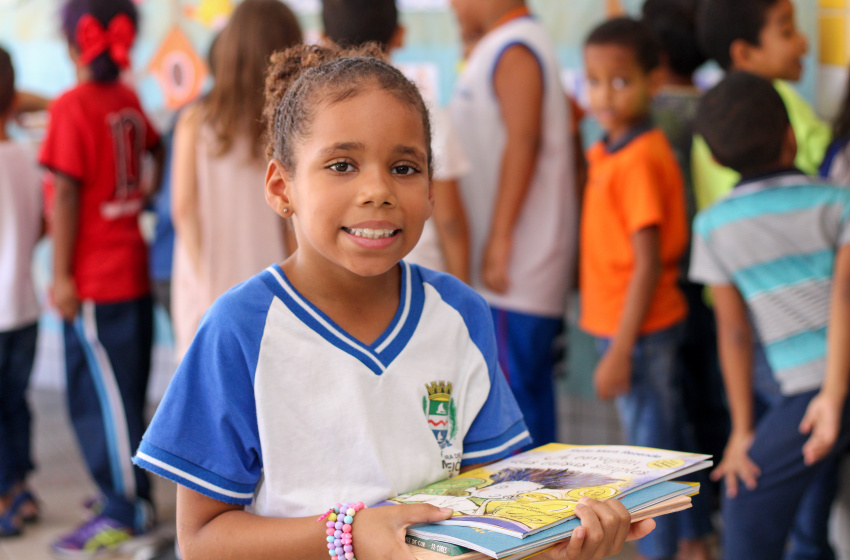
[579,125,688,337]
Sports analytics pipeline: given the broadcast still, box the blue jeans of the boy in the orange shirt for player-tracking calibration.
[596,323,712,558]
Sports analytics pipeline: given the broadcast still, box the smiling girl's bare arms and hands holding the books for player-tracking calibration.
[177,486,655,560]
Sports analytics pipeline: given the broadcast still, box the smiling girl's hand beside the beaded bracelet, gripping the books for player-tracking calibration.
[352,504,454,560]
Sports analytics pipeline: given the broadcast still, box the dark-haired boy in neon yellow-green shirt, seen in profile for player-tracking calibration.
[692,0,830,209]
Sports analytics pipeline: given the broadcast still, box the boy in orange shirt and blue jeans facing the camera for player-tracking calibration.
[579,18,711,559]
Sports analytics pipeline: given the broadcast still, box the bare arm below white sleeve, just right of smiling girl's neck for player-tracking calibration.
[433,180,469,284]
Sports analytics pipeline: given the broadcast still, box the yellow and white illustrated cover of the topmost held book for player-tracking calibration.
[390,443,710,536]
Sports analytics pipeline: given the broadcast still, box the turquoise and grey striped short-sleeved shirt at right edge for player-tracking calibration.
[690,170,850,396]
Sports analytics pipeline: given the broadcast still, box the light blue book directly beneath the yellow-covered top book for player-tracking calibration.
[407,482,699,560]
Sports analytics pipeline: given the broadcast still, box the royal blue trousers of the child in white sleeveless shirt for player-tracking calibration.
[492,308,564,445]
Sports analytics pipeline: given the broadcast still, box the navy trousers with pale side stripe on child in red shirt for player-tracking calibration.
[65,297,153,529]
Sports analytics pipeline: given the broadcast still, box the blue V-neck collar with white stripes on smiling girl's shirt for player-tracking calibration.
[263,261,425,375]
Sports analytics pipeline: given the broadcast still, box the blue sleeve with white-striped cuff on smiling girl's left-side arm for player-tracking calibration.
[133,281,271,505]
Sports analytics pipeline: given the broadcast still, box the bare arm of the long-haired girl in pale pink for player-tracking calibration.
[171,107,201,272]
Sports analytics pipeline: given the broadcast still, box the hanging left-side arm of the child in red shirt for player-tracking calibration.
[51,173,80,321]
